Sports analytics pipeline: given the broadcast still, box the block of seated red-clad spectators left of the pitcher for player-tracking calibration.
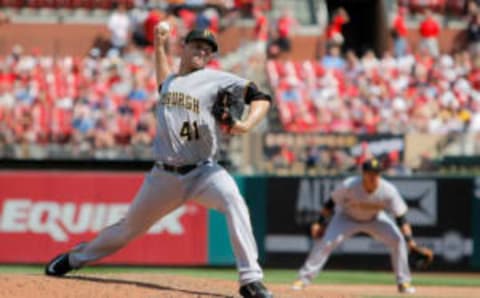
[0,43,161,158]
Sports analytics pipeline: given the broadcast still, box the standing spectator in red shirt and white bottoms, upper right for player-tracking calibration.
[419,9,440,57]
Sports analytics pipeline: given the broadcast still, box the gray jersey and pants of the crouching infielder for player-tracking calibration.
[299,176,411,284]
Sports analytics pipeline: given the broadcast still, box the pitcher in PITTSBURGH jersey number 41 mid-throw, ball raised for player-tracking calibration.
[45,24,272,298]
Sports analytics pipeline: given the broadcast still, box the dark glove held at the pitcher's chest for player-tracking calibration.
[212,89,245,128]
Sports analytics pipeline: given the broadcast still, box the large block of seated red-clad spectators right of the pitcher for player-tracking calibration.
[267,47,480,134]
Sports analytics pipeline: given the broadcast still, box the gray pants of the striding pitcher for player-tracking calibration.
[69,162,263,285]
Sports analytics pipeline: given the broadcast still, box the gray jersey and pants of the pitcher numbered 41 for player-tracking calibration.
[69,69,263,285]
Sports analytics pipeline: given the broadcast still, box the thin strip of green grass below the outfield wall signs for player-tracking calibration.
[0,265,480,287]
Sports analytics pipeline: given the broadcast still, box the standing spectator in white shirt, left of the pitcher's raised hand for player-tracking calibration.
[107,3,131,54]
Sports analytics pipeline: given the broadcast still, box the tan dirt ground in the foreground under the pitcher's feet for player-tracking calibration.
[0,274,480,298]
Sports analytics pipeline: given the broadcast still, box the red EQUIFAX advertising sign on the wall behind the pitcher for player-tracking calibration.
[0,171,207,265]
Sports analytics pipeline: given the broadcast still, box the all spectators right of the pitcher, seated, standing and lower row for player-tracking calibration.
[264,1,480,175]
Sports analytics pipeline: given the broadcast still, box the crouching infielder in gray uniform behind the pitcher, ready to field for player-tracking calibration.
[292,159,433,294]
